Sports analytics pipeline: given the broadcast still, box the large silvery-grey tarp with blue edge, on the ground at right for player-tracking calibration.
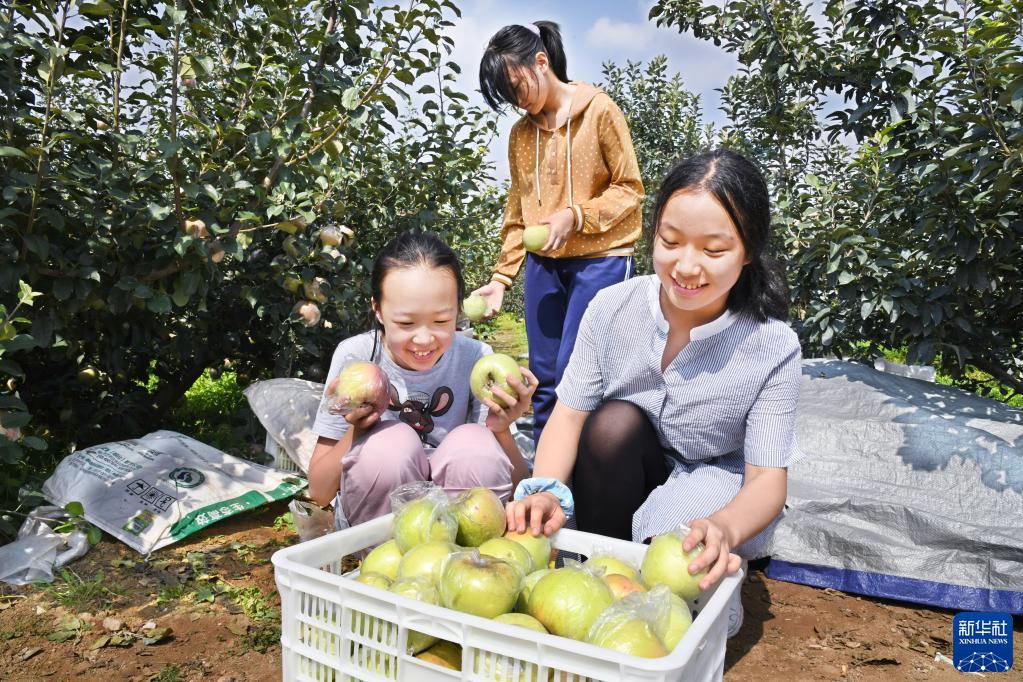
[767,360,1023,612]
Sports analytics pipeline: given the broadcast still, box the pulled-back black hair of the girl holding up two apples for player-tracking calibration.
[369,230,465,357]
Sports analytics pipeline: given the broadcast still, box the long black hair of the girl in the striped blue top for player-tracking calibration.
[650,149,789,322]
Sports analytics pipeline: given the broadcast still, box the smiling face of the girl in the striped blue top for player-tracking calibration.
[654,190,750,326]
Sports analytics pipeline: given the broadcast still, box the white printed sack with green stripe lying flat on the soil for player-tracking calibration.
[43,430,306,554]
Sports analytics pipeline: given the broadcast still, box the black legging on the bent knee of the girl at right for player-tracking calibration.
[572,400,668,540]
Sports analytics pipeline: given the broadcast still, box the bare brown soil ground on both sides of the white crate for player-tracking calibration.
[0,503,1023,682]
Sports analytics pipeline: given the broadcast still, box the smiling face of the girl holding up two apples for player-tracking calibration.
[372,265,458,371]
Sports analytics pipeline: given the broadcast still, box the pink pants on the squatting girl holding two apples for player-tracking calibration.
[340,420,512,526]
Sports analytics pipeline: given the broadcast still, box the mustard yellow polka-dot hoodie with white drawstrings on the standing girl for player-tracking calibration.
[492,81,643,286]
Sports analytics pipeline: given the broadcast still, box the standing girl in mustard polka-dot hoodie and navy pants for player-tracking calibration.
[476,21,643,442]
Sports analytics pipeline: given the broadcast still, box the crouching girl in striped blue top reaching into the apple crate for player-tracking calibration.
[507,149,803,642]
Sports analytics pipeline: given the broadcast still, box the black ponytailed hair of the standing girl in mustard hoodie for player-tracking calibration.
[480,21,569,110]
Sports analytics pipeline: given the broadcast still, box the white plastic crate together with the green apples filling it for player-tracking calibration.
[273,484,741,682]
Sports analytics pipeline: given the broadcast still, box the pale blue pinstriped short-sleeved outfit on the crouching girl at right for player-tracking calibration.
[558,275,804,558]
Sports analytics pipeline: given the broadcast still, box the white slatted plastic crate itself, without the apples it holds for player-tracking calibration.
[272,514,743,682]
